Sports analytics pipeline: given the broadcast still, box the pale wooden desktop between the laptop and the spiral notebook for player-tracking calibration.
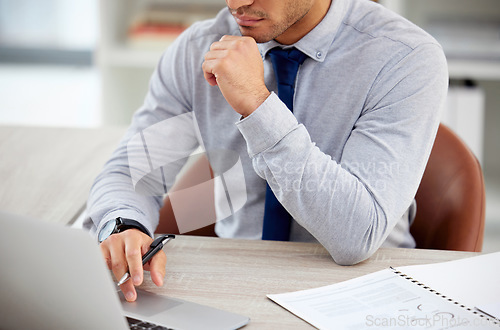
[142,236,476,329]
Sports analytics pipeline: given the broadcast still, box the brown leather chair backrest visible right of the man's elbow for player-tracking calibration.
[410,124,485,252]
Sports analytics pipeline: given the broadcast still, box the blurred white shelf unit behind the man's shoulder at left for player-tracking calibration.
[95,0,226,125]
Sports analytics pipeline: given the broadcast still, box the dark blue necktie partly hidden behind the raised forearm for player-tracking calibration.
[262,48,307,241]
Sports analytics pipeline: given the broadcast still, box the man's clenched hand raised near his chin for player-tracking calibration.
[202,36,270,117]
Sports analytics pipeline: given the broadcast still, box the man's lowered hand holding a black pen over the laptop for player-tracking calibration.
[100,229,167,301]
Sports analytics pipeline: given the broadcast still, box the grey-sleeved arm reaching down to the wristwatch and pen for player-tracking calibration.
[87,37,199,232]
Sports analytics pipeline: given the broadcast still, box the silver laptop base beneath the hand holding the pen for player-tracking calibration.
[119,290,249,329]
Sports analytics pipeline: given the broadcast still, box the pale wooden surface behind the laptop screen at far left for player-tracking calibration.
[0,126,125,223]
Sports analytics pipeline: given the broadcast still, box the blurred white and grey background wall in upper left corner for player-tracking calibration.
[0,0,101,127]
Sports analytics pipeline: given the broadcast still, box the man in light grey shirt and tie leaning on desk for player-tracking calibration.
[86,0,448,301]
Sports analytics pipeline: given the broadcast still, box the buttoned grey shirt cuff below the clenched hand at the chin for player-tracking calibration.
[236,92,298,157]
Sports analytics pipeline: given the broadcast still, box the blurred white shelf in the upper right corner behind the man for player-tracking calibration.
[379,0,500,81]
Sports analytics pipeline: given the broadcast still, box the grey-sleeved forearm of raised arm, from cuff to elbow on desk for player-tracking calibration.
[238,95,387,264]
